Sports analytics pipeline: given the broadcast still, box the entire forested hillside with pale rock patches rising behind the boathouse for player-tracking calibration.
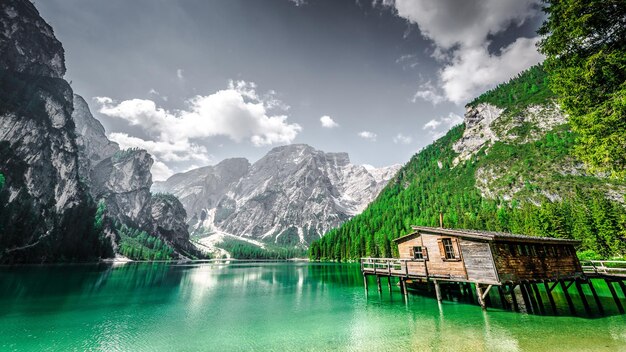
[309,67,626,260]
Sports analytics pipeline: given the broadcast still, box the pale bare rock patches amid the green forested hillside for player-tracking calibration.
[452,101,626,204]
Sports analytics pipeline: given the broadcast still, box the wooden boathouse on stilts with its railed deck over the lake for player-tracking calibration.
[361,226,626,313]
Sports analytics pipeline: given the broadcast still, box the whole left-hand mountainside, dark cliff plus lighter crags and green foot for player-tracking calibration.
[0,0,200,263]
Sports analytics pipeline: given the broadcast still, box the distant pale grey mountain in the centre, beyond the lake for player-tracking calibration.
[153,144,399,247]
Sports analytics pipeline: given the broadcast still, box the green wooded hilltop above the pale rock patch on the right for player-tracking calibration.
[468,65,554,113]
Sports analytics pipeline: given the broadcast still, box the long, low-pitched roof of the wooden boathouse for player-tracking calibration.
[394,226,581,245]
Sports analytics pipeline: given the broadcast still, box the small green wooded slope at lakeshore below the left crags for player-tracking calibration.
[115,224,174,260]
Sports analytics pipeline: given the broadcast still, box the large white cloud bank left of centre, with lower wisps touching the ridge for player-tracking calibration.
[94,81,302,179]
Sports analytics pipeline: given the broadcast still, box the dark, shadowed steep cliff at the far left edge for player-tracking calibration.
[0,0,106,262]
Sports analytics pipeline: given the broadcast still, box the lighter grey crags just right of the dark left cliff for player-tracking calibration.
[72,95,198,256]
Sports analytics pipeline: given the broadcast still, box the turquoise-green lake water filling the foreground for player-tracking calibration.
[0,263,626,351]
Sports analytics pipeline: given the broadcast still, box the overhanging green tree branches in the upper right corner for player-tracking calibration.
[539,0,626,179]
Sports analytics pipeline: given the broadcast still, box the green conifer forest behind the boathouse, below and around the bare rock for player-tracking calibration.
[309,115,626,261]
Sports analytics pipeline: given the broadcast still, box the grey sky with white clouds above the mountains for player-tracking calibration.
[35,0,542,180]
